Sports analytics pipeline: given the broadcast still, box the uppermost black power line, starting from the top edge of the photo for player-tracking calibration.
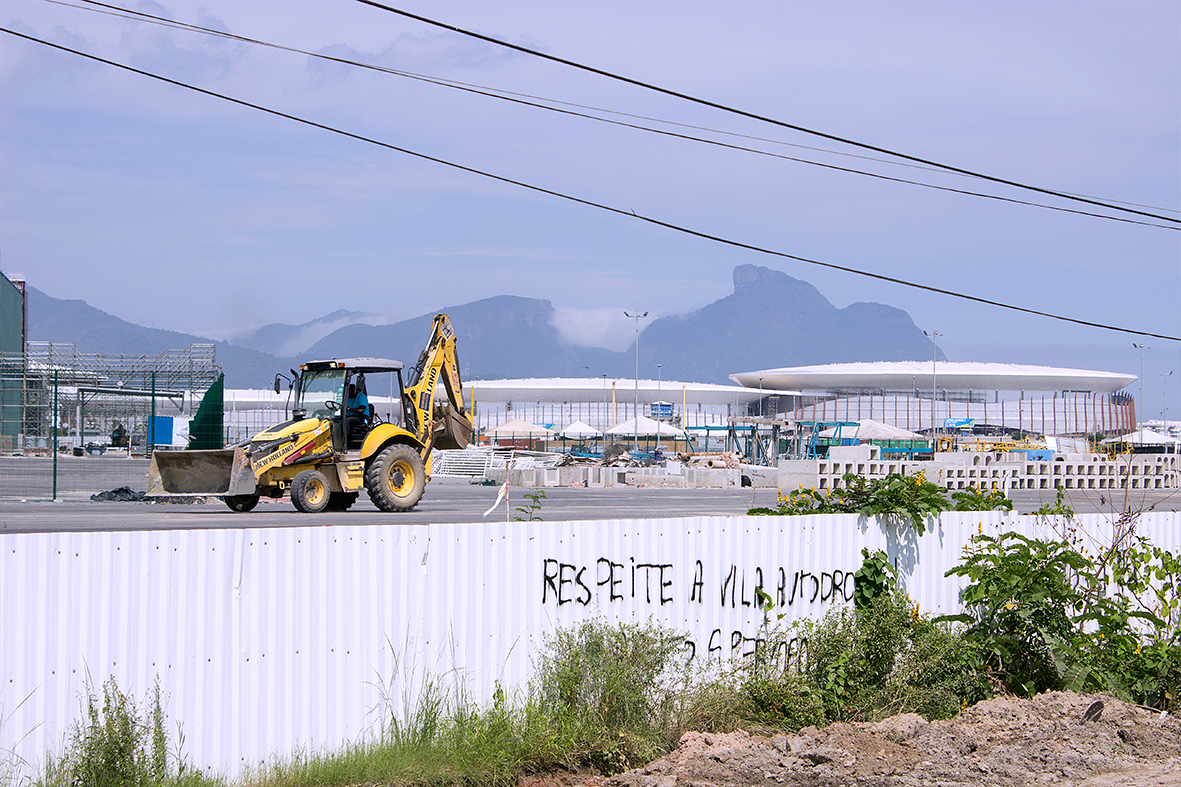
[355,0,1181,223]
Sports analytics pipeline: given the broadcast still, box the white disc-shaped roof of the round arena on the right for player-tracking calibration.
[730,360,1136,394]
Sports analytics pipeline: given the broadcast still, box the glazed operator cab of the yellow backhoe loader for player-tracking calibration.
[292,358,403,451]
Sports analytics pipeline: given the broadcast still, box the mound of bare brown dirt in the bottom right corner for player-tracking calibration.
[547,692,1181,787]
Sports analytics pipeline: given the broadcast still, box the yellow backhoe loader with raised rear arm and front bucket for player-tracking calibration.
[146,314,471,513]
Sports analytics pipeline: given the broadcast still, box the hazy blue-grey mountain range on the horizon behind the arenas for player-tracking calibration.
[28,265,942,388]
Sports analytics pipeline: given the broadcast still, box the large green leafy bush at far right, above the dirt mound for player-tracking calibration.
[947,533,1181,708]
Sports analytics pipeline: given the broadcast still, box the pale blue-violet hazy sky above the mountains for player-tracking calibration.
[0,0,1181,417]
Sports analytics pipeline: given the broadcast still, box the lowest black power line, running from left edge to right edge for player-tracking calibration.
[0,27,1181,342]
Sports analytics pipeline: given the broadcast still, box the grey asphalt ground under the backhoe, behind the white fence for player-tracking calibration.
[0,479,1181,534]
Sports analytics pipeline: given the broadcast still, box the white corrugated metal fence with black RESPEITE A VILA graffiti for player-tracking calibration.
[0,512,1181,775]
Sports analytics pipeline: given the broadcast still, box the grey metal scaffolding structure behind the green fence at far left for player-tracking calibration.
[0,342,221,454]
